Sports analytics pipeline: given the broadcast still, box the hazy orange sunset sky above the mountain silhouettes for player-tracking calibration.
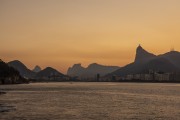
[0,0,180,73]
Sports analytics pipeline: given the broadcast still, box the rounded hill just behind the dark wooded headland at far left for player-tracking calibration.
[8,60,35,78]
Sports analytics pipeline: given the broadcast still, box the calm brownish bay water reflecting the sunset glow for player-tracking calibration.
[0,82,180,120]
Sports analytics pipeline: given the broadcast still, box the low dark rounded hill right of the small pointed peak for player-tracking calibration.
[36,67,65,79]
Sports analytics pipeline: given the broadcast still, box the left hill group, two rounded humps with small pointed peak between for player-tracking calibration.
[8,60,65,79]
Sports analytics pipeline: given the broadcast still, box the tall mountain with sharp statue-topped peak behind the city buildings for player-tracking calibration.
[107,45,180,76]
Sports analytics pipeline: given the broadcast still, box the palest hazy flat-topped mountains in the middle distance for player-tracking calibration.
[67,63,120,78]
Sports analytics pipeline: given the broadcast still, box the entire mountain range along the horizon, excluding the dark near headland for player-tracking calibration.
[4,45,180,79]
